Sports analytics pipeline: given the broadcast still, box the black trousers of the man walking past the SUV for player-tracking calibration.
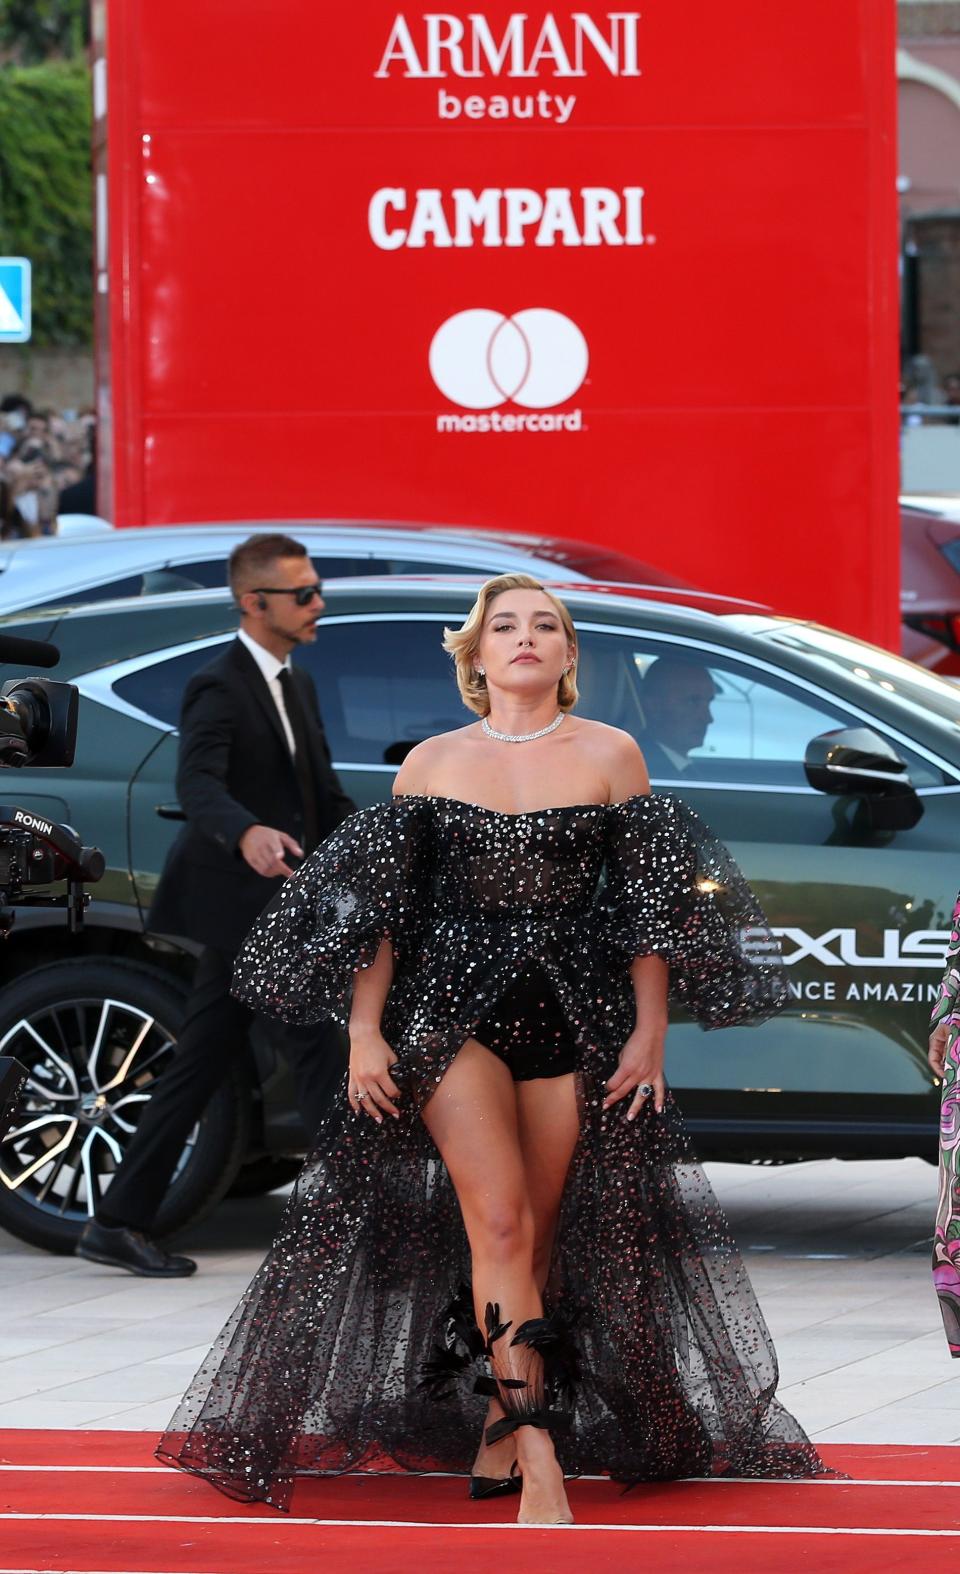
[98,948,346,1232]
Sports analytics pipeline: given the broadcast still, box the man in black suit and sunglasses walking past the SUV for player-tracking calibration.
[77,535,356,1278]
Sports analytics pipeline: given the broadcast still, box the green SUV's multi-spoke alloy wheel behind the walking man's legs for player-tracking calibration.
[0,959,250,1253]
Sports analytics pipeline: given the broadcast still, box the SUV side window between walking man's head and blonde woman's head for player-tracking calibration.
[296,619,472,765]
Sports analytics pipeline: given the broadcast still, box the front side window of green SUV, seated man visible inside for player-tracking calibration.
[579,633,943,787]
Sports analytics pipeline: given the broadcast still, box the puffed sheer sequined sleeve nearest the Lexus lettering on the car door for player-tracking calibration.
[600,793,788,1028]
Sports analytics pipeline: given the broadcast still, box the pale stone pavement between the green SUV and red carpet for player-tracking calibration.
[0,1158,960,1443]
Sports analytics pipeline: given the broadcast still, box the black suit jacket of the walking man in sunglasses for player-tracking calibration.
[146,639,356,951]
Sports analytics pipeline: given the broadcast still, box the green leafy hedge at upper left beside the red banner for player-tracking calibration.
[0,60,93,345]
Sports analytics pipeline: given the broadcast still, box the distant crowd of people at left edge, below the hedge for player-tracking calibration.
[0,394,96,540]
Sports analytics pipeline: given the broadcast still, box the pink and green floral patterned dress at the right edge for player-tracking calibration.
[930,897,960,1357]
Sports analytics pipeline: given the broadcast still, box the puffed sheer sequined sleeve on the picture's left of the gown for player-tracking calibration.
[233,798,428,1026]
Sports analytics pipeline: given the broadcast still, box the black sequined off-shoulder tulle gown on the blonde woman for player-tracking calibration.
[159,795,823,1508]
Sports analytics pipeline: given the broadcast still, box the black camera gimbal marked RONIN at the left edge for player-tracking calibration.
[0,804,104,937]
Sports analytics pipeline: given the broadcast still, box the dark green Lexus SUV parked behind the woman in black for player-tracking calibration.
[0,578,960,1250]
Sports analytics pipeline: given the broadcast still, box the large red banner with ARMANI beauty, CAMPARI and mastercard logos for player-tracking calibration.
[104,0,899,644]
